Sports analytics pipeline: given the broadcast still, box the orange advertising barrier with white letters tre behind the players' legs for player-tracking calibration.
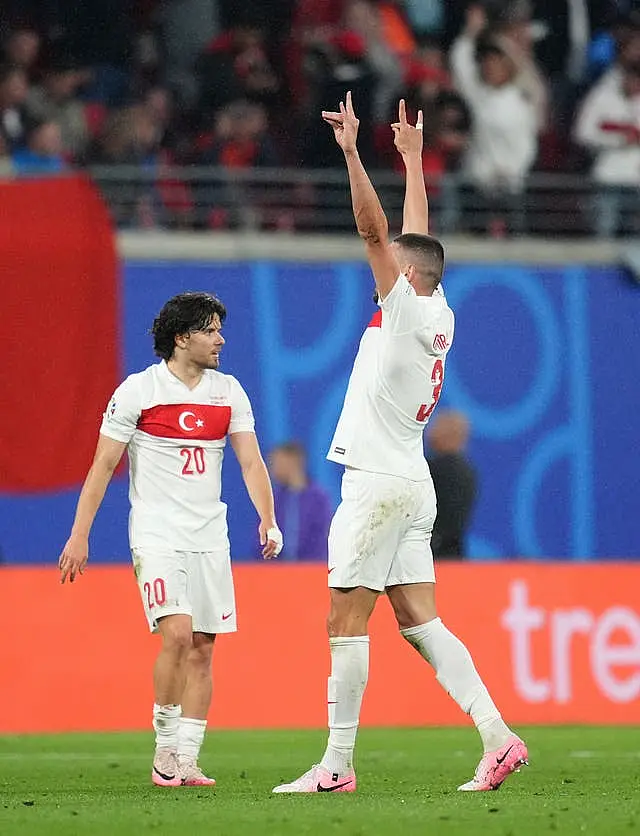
[0,563,640,732]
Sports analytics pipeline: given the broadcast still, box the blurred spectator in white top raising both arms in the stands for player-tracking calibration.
[451,6,541,235]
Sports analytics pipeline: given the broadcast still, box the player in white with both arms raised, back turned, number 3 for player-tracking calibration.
[274,93,527,793]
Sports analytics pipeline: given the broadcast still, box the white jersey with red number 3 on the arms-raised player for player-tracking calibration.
[327,275,454,480]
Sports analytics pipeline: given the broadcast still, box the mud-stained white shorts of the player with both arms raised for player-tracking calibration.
[329,469,436,592]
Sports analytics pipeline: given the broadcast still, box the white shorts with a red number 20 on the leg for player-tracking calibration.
[132,548,237,633]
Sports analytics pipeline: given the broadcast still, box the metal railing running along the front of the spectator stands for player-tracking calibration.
[88,166,640,238]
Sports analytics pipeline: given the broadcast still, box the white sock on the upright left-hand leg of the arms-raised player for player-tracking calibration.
[320,636,369,775]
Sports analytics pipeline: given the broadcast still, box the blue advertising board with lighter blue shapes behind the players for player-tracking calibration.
[0,262,640,563]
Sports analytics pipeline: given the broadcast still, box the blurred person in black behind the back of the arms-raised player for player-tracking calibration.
[427,410,477,559]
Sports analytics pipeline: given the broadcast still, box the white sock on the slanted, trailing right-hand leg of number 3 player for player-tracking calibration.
[400,618,512,752]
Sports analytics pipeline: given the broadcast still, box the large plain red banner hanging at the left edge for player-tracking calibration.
[0,177,120,491]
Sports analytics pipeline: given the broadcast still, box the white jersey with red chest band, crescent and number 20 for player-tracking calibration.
[100,361,254,551]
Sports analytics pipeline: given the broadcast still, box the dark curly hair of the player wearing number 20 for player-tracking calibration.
[151,293,227,360]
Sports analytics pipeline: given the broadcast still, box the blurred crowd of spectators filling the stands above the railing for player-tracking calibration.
[0,0,640,235]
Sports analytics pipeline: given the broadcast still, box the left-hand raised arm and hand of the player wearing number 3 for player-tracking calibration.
[322,92,399,299]
